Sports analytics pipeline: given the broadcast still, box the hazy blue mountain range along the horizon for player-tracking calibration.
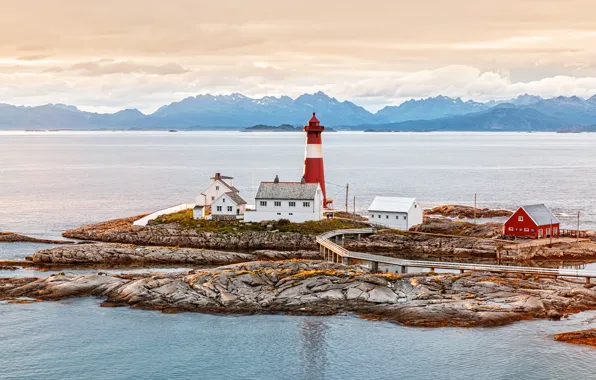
[0,92,596,131]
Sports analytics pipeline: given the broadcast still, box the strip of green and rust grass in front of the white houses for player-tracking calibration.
[149,209,367,235]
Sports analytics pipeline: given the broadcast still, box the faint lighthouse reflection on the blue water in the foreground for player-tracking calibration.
[299,318,328,380]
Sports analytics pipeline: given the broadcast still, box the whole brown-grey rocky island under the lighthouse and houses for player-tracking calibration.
[0,205,596,327]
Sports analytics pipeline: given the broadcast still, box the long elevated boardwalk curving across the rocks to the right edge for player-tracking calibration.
[316,228,596,284]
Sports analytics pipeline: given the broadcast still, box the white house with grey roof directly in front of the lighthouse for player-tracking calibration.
[244,176,323,223]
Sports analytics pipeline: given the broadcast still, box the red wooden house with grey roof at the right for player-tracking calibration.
[503,204,560,239]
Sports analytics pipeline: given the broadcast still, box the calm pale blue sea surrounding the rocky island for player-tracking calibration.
[0,131,596,380]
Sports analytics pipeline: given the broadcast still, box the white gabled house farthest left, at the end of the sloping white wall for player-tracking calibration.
[193,173,246,219]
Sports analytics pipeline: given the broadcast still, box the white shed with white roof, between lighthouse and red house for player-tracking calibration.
[368,197,423,231]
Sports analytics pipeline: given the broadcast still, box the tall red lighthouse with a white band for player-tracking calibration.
[303,112,327,207]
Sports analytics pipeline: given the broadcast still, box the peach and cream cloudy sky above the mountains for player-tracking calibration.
[0,0,596,113]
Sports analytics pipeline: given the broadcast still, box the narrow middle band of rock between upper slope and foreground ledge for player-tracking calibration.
[32,243,319,266]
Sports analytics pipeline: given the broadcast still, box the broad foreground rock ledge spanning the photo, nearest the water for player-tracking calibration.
[0,260,596,327]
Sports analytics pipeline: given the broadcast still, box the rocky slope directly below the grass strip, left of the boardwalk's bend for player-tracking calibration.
[62,217,317,251]
